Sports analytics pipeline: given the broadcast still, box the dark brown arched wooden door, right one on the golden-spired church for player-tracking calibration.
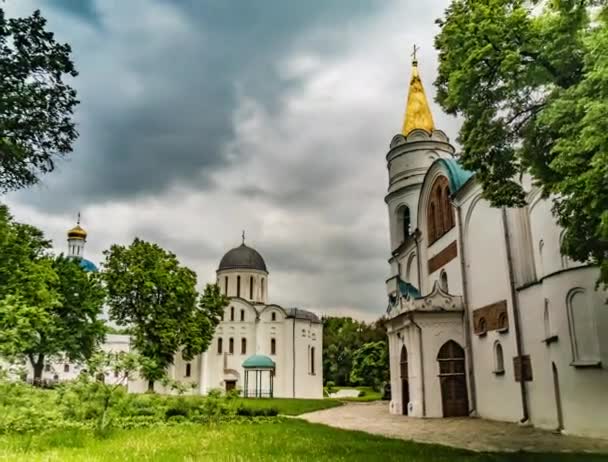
[437,340,469,417]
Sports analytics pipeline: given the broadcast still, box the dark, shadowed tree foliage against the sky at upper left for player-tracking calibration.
[0,8,78,192]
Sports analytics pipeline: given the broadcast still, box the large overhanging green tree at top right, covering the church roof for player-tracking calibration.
[435,0,608,284]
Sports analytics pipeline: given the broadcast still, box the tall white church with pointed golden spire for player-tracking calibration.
[385,56,608,436]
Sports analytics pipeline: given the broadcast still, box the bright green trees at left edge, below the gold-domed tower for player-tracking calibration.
[0,207,105,381]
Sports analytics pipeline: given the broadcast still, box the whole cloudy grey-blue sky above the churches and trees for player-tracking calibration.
[3,0,458,320]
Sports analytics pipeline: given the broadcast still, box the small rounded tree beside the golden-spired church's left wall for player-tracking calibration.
[350,340,389,391]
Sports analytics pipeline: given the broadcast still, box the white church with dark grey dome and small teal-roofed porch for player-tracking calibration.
[129,239,323,399]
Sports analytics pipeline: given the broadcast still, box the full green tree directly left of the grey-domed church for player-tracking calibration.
[103,239,228,391]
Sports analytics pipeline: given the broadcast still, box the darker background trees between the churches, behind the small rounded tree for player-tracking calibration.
[323,317,386,386]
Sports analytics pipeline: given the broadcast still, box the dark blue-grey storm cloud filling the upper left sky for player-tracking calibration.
[17,0,379,210]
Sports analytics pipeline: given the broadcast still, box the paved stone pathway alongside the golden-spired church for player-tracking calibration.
[300,401,608,453]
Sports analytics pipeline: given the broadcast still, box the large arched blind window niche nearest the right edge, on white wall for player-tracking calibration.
[567,288,600,366]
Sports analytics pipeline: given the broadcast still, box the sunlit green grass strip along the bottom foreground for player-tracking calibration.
[0,418,608,462]
